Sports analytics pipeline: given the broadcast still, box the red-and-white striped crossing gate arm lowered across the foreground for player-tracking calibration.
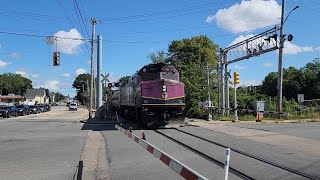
[115,125,207,180]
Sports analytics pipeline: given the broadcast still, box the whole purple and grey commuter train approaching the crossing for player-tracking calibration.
[111,63,185,128]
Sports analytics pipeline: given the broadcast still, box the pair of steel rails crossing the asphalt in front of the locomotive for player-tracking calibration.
[154,128,318,180]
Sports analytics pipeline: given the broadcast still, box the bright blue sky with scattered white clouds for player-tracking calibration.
[0,0,320,96]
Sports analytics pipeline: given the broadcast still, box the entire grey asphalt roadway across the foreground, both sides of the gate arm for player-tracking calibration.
[0,106,320,180]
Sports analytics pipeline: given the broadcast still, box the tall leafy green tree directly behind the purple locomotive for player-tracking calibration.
[167,36,219,117]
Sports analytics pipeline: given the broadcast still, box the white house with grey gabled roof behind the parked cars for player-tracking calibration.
[24,88,49,105]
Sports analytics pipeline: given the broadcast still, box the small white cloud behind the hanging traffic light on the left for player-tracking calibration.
[54,29,84,54]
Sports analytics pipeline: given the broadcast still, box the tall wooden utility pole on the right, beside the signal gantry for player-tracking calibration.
[277,0,285,117]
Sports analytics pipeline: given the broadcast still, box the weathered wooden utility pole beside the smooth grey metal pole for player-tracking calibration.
[89,18,97,118]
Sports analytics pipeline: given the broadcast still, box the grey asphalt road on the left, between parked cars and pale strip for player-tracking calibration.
[0,106,87,180]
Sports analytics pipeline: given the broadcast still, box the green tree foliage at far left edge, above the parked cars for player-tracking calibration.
[0,73,32,95]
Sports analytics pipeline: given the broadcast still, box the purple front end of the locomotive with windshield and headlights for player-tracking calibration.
[139,64,185,127]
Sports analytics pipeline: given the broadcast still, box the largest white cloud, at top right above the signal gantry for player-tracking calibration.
[206,0,281,33]
